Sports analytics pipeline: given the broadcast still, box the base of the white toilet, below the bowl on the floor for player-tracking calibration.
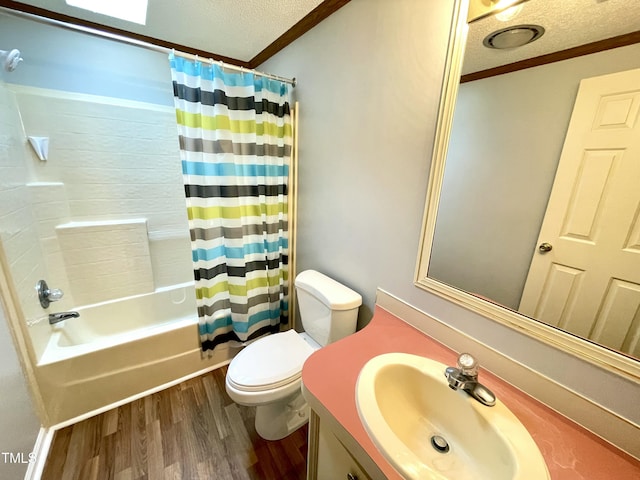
[256,393,309,440]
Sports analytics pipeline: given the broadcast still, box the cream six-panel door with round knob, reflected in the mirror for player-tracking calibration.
[519,69,640,356]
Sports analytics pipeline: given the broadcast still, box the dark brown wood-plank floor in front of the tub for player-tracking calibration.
[42,367,308,480]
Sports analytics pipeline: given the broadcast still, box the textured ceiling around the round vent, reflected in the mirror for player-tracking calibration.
[462,0,640,74]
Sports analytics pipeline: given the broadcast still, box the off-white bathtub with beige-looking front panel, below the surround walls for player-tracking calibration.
[36,282,235,425]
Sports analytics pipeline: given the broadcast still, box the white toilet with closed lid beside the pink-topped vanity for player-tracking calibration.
[225,270,362,440]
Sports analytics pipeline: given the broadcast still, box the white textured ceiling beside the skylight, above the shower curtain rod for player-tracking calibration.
[11,0,322,61]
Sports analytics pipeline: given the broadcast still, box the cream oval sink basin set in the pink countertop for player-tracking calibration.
[356,353,550,480]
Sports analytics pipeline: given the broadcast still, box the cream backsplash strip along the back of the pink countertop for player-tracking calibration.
[376,289,640,459]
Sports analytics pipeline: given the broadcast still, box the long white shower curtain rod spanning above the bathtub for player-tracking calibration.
[0,7,296,87]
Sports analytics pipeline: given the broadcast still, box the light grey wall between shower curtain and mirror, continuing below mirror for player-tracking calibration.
[260,0,640,446]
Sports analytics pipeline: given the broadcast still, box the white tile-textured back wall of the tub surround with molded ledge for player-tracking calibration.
[8,85,193,358]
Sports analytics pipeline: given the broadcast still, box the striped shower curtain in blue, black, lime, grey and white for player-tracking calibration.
[169,55,292,353]
